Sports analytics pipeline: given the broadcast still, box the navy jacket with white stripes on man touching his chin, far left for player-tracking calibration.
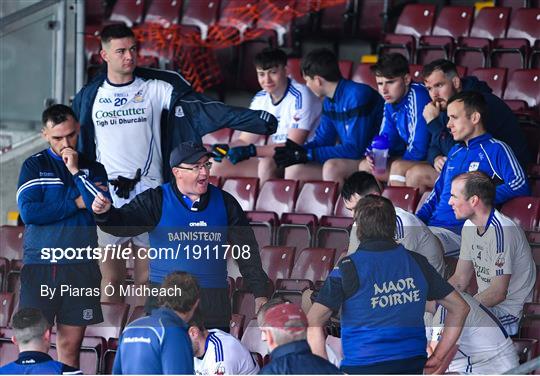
[17,149,110,264]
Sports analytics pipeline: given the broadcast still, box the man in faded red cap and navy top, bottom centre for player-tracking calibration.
[257,300,341,375]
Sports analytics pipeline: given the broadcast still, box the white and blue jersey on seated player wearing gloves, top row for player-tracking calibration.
[249,78,322,144]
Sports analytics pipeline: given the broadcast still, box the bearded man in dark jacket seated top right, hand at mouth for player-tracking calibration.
[405,59,530,192]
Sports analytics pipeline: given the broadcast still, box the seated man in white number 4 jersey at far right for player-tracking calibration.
[448,171,536,335]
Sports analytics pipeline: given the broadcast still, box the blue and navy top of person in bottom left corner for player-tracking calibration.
[0,351,82,375]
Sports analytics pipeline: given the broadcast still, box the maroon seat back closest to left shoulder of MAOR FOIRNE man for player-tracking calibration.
[291,248,336,281]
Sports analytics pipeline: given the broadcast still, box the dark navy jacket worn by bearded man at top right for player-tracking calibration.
[428,76,530,170]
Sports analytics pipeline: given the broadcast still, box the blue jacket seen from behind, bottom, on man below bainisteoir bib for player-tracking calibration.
[113,308,195,375]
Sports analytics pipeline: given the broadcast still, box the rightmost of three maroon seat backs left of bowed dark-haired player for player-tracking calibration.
[294,181,338,218]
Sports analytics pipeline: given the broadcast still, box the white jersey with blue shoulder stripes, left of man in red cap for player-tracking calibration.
[194,329,259,375]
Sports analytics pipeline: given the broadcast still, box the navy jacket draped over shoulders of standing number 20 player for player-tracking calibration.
[72,68,278,181]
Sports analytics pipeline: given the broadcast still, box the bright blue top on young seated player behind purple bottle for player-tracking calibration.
[380,84,431,161]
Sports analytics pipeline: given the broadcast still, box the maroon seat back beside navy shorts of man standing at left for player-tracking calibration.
[85,302,129,340]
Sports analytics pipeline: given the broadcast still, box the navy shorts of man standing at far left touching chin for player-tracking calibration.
[19,262,103,326]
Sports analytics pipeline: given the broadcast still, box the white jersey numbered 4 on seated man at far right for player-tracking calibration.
[459,210,536,318]
